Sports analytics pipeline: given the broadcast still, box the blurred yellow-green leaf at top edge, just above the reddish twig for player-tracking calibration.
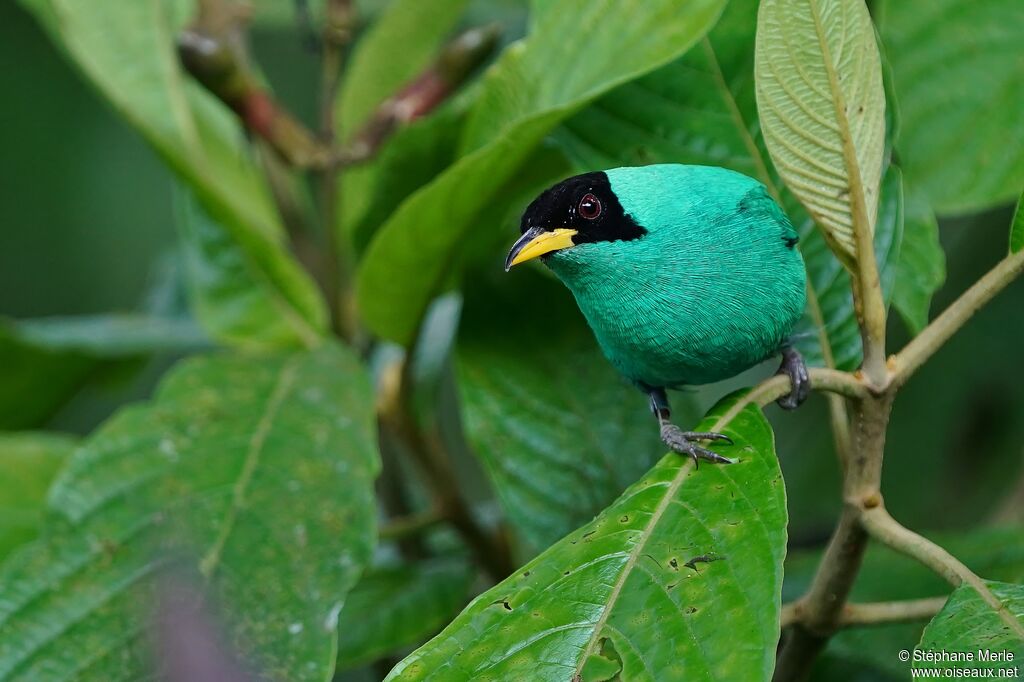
[335,0,468,133]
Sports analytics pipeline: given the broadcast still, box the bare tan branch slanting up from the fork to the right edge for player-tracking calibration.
[892,250,1024,387]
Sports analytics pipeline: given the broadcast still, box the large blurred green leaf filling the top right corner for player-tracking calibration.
[877,0,1024,215]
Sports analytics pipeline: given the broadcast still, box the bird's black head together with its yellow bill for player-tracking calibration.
[505,171,647,270]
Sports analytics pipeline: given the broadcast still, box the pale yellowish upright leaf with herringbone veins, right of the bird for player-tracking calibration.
[755,0,886,263]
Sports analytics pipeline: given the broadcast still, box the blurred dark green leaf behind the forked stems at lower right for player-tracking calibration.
[783,526,1024,680]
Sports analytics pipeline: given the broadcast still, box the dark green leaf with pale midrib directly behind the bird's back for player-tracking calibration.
[555,0,905,369]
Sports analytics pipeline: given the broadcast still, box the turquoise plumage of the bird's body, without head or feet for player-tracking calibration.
[547,164,806,386]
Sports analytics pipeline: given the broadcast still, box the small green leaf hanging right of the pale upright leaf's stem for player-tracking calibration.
[893,188,946,334]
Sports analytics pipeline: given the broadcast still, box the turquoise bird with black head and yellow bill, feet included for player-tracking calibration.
[505,164,810,465]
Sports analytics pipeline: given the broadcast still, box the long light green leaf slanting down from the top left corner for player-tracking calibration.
[23,0,327,345]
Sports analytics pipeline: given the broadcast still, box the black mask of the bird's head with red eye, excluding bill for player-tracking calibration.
[519,171,647,244]
